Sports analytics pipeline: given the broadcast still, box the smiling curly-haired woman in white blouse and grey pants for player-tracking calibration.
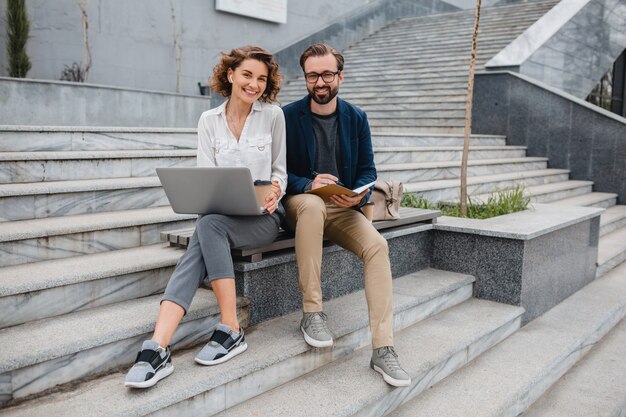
[125,46,287,388]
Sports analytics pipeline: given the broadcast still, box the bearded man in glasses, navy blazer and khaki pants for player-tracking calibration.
[283,44,411,386]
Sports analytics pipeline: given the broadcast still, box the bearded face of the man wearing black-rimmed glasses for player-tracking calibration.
[304,54,343,104]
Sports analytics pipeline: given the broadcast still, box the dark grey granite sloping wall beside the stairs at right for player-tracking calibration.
[472,72,626,204]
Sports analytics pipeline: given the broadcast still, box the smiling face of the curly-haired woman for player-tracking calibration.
[228,58,268,104]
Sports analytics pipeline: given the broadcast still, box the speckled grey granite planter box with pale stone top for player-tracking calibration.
[431,204,604,324]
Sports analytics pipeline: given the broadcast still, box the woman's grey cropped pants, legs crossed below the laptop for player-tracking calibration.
[161,211,282,313]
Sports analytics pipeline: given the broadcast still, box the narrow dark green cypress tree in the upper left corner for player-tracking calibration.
[6,0,31,78]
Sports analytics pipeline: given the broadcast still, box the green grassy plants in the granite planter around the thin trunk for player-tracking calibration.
[401,185,530,219]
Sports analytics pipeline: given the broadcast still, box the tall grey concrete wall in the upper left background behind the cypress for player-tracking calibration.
[0,0,378,94]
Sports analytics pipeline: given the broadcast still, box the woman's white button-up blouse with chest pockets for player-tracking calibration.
[197,101,287,197]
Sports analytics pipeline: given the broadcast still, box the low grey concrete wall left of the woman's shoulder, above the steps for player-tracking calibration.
[0,77,211,128]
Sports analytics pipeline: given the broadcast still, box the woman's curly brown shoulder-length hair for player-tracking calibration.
[209,45,282,103]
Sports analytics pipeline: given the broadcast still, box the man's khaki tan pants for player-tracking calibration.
[284,194,393,349]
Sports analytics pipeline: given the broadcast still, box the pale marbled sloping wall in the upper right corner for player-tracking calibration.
[486,0,626,98]
